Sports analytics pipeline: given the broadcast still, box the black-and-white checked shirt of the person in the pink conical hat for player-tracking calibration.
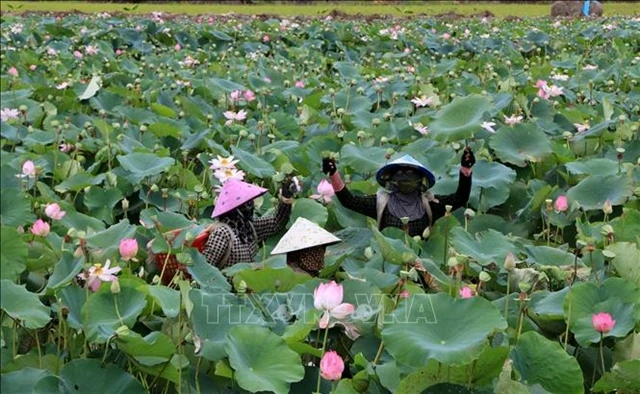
[202,201,291,269]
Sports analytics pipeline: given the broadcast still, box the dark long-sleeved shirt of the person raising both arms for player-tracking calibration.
[336,170,471,237]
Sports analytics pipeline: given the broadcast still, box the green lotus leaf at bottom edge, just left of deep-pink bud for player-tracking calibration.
[226,326,304,393]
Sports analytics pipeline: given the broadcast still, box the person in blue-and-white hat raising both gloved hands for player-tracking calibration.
[322,147,476,237]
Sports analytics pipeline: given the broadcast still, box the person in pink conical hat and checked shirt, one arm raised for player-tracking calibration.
[202,178,296,269]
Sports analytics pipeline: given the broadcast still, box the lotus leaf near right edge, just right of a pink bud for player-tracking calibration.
[567,175,633,210]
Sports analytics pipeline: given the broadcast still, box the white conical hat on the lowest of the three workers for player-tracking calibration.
[271,217,341,254]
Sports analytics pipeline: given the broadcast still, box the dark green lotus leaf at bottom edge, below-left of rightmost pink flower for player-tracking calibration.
[511,331,584,394]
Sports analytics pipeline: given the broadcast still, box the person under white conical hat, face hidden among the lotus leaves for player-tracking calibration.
[271,217,341,276]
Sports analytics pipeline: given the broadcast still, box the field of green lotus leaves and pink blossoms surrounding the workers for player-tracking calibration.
[0,9,640,393]
